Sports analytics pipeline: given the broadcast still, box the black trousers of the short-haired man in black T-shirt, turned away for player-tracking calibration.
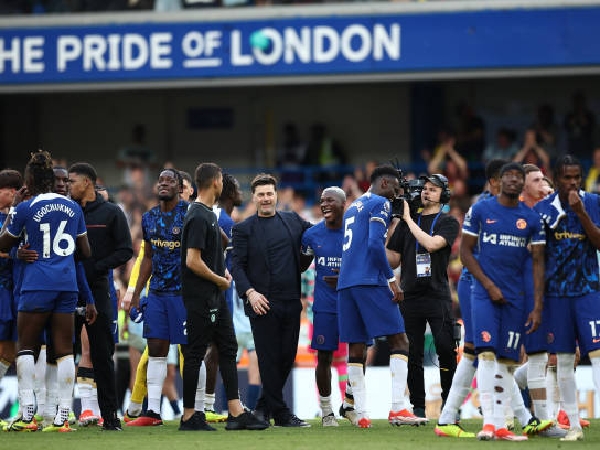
[182,295,239,409]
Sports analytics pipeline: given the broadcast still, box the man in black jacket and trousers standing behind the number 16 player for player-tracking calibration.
[69,162,133,431]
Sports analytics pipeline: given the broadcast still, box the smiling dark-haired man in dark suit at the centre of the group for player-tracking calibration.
[232,173,312,427]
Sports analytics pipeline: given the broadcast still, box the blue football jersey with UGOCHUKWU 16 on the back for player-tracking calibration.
[7,193,87,292]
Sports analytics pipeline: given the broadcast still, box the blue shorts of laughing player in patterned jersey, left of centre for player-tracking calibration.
[144,291,187,344]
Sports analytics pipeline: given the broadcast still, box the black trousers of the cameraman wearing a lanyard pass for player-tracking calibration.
[400,293,456,408]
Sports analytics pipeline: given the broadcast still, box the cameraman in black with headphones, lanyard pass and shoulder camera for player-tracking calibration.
[386,174,459,417]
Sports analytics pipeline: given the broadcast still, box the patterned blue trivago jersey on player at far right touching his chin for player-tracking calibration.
[533,192,600,297]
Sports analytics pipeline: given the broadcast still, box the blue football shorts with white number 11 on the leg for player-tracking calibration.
[471,292,525,361]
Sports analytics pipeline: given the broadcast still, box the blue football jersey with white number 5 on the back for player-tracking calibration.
[338,192,394,290]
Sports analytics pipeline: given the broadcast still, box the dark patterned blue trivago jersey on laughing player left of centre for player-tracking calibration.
[142,200,188,292]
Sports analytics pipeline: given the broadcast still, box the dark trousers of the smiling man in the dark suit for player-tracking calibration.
[250,300,302,424]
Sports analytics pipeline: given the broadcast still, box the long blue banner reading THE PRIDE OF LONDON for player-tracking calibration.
[0,7,600,85]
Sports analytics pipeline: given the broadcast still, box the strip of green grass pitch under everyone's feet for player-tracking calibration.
[0,419,600,450]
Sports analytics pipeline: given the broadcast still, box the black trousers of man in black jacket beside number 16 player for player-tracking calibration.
[85,286,118,419]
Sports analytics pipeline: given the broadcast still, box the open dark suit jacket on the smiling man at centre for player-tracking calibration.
[231,211,312,317]
